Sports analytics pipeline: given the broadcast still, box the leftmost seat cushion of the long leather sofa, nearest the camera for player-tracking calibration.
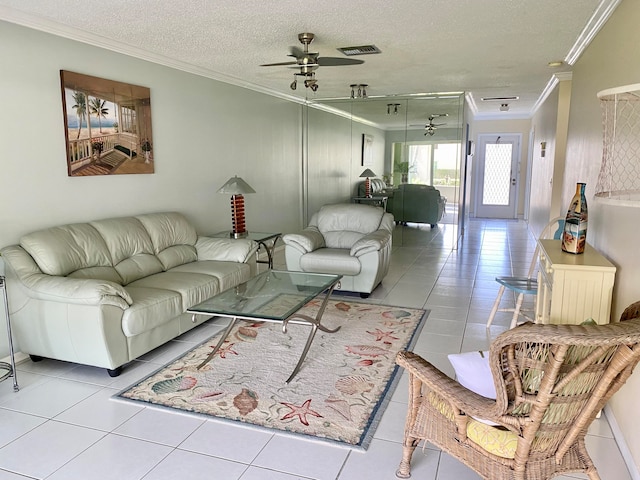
[122,286,184,337]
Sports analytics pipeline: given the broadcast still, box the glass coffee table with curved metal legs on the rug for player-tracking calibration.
[187,270,342,383]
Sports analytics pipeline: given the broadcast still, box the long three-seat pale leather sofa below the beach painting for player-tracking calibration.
[1,212,258,376]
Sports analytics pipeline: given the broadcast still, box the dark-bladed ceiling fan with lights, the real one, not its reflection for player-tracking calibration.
[260,33,364,92]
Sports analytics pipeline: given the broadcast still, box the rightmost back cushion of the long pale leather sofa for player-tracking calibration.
[136,212,198,270]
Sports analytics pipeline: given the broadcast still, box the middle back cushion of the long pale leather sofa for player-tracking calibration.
[91,217,164,285]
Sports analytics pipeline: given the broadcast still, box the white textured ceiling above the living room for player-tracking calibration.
[0,0,619,122]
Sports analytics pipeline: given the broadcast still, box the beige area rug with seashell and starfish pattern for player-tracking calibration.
[115,299,428,448]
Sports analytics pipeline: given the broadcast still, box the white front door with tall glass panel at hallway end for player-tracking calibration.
[475,134,520,218]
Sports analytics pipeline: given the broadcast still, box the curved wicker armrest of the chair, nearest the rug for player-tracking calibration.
[396,351,504,426]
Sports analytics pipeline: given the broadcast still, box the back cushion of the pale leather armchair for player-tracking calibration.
[312,203,384,248]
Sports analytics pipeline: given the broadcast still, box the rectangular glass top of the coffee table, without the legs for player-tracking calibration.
[187,270,342,321]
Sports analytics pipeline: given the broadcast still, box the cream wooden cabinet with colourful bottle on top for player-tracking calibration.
[536,240,616,324]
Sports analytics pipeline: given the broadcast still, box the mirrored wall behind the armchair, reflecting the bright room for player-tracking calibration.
[303,92,466,248]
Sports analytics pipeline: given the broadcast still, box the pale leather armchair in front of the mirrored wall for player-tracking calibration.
[282,203,395,298]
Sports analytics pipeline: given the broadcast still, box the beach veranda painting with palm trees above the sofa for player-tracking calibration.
[60,70,154,177]
